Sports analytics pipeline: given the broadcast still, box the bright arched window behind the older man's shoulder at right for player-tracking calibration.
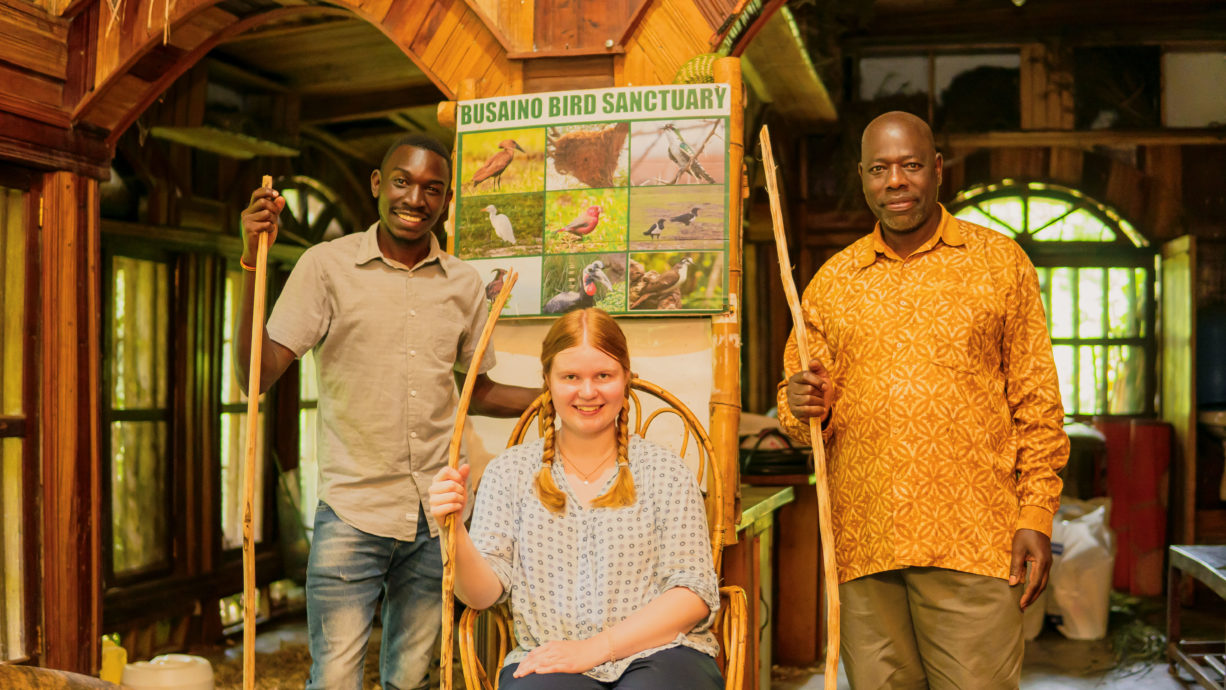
[949,180,1155,415]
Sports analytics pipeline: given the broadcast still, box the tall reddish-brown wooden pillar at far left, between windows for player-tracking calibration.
[40,172,102,675]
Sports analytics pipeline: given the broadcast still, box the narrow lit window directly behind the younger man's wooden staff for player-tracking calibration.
[221,263,267,549]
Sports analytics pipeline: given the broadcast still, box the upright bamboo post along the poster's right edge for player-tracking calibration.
[710,58,747,543]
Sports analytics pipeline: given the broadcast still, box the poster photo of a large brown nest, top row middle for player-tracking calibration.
[546,123,630,190]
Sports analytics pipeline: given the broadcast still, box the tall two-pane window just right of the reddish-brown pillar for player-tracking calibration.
[103,251,172,576]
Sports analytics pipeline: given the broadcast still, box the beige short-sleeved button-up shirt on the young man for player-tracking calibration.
[267,223,494,540]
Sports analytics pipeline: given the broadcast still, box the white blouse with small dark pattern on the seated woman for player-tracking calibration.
[470,436,720,683]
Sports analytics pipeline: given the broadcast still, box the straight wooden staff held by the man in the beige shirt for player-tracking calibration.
[243,175,272,690]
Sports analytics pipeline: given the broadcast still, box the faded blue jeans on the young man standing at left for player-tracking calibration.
[307,501,443,690]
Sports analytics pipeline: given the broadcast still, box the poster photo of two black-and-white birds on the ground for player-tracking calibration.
[630,185,728,251]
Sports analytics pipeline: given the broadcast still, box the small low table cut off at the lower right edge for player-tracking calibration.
[1166,547,1226,690]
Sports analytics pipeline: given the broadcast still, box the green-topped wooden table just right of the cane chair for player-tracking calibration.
[723,485,796,690]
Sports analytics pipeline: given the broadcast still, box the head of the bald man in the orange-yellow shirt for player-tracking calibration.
[859,113,943,241]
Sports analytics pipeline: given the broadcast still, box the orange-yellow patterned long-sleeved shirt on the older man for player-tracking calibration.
[779,208,1069,582]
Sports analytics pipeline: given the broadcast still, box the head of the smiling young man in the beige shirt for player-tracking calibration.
[370,145,451,251]
